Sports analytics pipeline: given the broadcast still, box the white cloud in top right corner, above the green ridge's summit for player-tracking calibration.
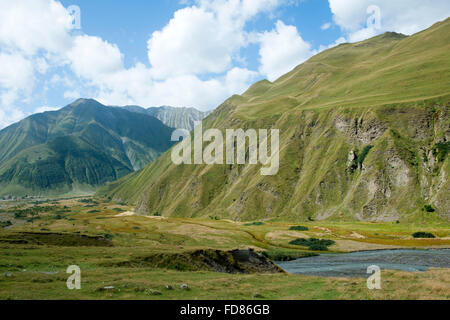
[329,0,450,42]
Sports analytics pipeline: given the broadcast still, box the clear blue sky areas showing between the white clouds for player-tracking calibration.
[61,0,340,69]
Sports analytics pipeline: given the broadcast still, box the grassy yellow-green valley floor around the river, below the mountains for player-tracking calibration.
[0,198,450,299]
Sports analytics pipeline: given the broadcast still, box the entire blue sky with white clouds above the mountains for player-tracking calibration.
[0,0,450,129]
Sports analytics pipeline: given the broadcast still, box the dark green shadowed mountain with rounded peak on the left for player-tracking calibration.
[0,99,173,195]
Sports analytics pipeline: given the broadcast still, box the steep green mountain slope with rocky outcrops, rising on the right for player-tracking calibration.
[99,19,450,221]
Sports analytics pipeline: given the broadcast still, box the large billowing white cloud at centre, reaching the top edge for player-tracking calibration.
[148,0,281,79]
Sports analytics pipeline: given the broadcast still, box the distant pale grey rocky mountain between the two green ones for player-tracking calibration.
[124,106,209,131]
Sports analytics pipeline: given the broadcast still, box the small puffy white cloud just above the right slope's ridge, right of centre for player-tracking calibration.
[258,21,314,81]
